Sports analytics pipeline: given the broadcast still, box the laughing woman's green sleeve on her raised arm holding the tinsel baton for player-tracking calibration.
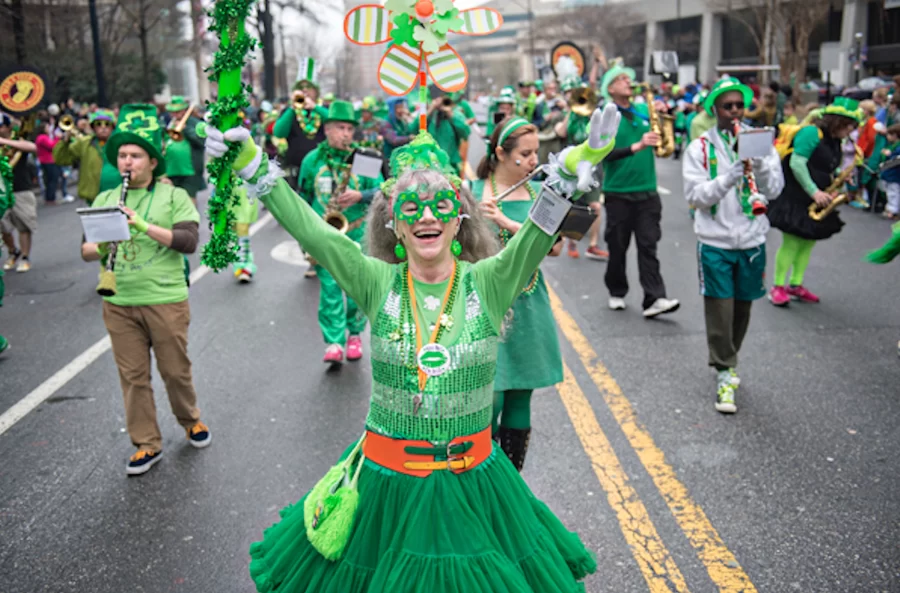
[260,179,394,319]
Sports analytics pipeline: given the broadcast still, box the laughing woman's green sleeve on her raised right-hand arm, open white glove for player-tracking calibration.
[473,219,556,329]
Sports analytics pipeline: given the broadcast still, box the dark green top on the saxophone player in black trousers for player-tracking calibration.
[603,104,656,194]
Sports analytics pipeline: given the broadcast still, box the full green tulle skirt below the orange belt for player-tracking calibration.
[250,446,597,593]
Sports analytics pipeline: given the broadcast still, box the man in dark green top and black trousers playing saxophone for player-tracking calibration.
[601,64,679,319]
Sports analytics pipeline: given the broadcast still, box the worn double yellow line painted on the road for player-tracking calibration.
[547,285,756,593]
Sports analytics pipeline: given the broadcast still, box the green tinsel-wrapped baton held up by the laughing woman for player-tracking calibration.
[200,0,257,272]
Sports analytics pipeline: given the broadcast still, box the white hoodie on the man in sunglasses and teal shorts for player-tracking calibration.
[682,128,784,250]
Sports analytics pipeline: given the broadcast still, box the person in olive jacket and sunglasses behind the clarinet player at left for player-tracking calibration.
[53,109,122,204]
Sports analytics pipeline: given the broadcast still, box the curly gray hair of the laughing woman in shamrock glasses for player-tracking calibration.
[364,169,500,264]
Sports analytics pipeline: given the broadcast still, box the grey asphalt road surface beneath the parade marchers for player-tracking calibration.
[0,154,900,593]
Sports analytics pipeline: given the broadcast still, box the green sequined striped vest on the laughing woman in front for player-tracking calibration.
[366,262,498,443]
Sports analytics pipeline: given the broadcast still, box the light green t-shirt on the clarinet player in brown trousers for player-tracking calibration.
[91,183,200,307]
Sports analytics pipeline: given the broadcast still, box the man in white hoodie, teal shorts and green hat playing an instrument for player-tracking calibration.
[682,78,784,414]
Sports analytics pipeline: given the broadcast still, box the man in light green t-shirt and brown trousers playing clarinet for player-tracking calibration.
[81,105,211,475]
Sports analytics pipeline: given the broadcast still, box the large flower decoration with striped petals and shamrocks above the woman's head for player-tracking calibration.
[344,0,503,96]
